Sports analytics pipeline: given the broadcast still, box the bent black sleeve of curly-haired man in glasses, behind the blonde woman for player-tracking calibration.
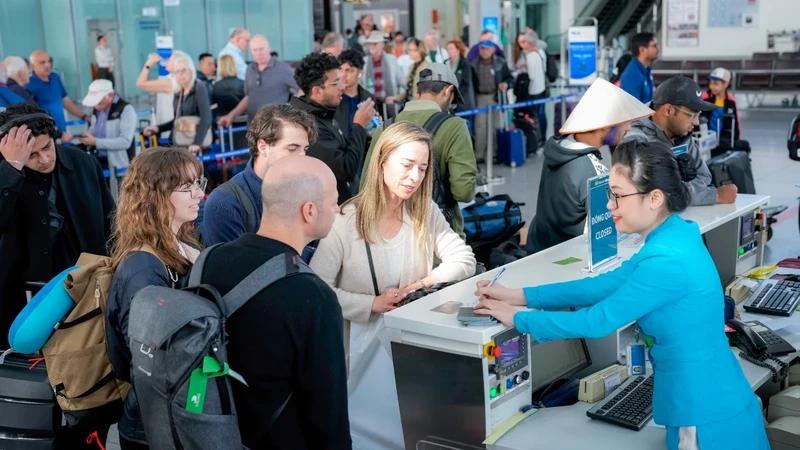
[308,122,367,182]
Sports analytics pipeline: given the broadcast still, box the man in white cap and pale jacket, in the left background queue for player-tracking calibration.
[77,80,137,169]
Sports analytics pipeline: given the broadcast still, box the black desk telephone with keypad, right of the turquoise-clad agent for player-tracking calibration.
[727,319,794,383]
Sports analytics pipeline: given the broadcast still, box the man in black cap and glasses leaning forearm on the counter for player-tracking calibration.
[625,75,737,206]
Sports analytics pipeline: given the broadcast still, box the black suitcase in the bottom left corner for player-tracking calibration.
[0,353,61,450]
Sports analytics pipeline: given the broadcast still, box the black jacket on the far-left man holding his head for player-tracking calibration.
[0,146,115,348]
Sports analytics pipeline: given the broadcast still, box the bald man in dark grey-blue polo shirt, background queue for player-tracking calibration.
[217,34,300,127]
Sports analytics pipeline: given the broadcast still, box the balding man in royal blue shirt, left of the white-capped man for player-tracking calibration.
[27,50,91,142]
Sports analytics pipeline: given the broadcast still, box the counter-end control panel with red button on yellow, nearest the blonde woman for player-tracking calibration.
[484,329,531,408]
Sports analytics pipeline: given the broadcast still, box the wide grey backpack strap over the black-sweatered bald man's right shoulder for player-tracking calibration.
[222,253,314,318]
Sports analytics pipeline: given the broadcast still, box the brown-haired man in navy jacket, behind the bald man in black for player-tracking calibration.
[200,105,317,246]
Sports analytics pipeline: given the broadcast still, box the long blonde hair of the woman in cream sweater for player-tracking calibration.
[342,122,433,250]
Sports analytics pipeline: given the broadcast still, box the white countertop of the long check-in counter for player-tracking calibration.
[384,195,769,345]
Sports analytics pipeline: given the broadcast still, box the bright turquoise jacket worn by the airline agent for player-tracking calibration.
[514,214,753,427]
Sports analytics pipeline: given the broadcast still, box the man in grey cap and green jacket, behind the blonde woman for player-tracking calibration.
[361,63,478,238]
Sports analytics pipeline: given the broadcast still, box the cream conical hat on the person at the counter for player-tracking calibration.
[556,78,654,134]
